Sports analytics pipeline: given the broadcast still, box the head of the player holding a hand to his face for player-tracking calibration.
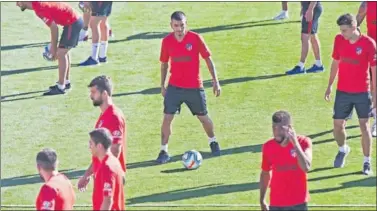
[272,110,292,143]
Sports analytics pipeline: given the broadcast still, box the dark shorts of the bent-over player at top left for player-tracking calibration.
[59,17,84,49]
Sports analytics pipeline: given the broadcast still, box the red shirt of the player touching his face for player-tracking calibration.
[262,136,311,207]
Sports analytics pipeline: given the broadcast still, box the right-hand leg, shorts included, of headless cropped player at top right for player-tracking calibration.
[306,7,325,73]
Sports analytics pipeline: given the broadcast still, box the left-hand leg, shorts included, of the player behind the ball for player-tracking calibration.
[156,86,182,163]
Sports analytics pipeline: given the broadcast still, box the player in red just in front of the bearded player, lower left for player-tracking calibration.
[89,128,125,210]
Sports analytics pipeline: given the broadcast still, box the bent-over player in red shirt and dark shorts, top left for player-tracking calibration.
[17,1,83,95]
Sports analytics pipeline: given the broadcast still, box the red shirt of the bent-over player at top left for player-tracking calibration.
[31,1,80,26]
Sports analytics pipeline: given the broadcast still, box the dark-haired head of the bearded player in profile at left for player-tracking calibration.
[88,75,113,106]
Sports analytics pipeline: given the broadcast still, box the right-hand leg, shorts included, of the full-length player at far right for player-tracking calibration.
[354,93,372,175]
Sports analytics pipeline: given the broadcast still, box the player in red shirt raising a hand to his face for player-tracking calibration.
[260,111,312,211]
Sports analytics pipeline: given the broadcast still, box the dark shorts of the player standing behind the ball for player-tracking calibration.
[164,85,208,116]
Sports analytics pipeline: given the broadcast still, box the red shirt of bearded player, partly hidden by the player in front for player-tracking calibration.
[92,105,126,172]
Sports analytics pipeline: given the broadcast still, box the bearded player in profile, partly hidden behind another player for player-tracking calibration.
[78,75,127,191]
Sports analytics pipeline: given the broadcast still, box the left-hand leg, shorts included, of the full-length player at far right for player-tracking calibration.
[333,91,354,168]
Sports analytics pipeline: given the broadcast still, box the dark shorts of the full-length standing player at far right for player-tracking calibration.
[333,90,372,120]
